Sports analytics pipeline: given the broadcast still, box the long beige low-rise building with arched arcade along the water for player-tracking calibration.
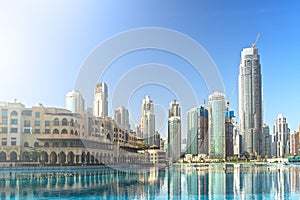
[0,102,144,166]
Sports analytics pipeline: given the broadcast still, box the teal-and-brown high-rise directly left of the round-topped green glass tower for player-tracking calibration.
[187,106,208,155]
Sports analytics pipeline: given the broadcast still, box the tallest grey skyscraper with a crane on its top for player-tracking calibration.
[239,46,264,155]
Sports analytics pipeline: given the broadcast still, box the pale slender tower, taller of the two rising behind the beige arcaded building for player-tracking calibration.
[94,83,108,117]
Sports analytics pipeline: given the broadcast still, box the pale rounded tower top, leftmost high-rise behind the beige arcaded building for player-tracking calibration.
[66,90,85,113]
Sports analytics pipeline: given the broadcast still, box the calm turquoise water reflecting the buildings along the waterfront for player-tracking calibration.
[0,164,300,199]
